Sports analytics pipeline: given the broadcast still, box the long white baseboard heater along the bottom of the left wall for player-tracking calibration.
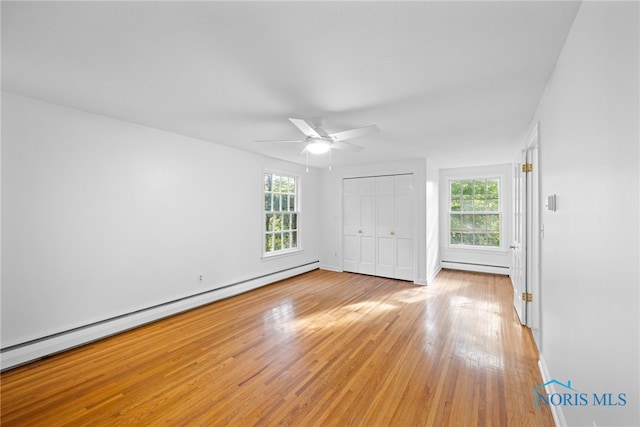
[0,261,320,370]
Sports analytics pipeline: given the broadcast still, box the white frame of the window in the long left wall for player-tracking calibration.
[260,169,303,260]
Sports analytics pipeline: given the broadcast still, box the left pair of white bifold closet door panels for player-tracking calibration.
[343,177,376,274]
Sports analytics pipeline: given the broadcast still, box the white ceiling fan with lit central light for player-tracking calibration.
[255,118,379,155]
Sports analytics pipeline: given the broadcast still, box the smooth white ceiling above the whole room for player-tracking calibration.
[1,1,579,166]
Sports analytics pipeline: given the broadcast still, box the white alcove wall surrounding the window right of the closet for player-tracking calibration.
[440,164,513,274]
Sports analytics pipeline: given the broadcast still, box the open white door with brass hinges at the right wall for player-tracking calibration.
[510,155,527,325]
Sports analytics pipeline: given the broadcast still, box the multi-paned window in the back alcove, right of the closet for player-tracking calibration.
[449,178,500,247]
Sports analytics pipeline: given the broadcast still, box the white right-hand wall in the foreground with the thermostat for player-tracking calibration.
[533,2,640,426]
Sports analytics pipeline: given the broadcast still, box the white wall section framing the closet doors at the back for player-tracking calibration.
[320,160,427,284]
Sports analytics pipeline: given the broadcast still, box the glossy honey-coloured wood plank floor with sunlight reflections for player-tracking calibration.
[0,270,553,426]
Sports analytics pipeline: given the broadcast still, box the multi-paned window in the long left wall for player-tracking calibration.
[264,173,299,255]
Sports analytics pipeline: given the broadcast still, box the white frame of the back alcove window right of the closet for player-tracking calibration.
[445,173,507,252]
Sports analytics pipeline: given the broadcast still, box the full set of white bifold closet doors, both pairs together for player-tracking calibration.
[343,174,414,280]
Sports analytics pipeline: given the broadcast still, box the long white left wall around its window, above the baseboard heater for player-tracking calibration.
[2,93,320,362]
